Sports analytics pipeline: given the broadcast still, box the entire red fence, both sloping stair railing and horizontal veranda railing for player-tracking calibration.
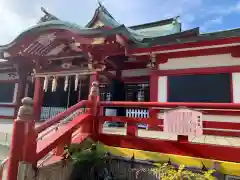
[4,96,240,180]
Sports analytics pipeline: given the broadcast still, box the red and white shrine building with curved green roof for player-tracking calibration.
[0,4,240,121]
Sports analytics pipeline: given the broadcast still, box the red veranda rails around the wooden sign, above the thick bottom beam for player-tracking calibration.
[100,102,240,137]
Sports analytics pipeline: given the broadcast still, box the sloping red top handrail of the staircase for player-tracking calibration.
[36,100,89,134]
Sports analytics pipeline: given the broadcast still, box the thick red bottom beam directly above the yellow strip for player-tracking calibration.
[98,134,240,162]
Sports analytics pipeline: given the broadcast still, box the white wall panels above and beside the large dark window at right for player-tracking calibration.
[158,54,240,114]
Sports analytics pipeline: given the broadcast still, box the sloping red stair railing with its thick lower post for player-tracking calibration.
[4,100,94,180]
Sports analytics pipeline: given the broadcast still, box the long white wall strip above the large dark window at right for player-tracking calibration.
[158,54,240,70]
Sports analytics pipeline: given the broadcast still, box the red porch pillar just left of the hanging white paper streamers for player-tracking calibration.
[33,77,44,121]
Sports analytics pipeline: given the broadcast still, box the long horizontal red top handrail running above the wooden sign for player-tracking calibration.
[100,101,240,110]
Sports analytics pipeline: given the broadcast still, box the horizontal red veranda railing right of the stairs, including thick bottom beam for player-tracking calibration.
[98,102,240,162]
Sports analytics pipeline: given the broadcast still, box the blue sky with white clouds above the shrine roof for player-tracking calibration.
[0,0,240,44]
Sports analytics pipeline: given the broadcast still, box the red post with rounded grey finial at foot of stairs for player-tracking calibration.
[7,97,36,180]
